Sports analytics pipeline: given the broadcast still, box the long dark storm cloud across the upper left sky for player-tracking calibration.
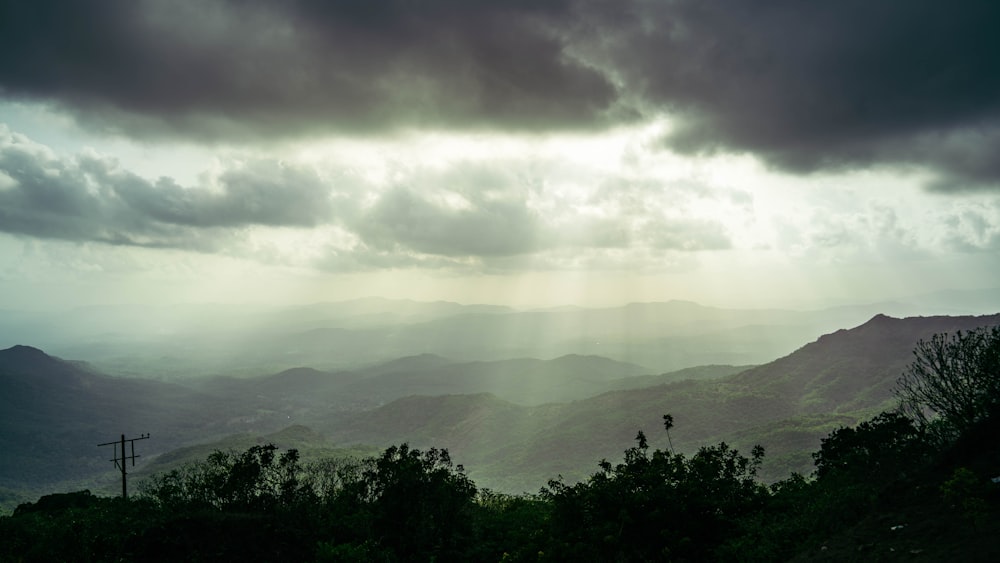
[0,0,615,137]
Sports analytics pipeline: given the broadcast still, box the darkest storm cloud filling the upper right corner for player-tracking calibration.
[590,0,1000,189]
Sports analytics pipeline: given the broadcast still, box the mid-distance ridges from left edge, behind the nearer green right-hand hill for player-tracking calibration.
[0,345,645,492]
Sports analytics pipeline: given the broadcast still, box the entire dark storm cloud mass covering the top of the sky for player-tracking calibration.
[0,0,1000,191]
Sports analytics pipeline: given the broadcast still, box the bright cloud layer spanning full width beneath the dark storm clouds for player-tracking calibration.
[7,127,1000,280]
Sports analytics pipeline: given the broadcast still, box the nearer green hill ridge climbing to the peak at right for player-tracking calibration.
[324,315,1000,490]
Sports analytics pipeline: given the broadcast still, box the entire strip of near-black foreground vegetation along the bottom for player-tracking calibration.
[0,328,1000,562]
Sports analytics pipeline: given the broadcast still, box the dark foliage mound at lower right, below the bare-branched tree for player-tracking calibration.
[718,412,1000,561]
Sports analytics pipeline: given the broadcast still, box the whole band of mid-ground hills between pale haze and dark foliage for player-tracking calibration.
[0,315,1000,502]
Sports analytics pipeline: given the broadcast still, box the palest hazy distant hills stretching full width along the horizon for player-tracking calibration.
[0,292,984,379]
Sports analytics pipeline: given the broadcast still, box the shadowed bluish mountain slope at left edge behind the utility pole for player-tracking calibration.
[0,346,286,486]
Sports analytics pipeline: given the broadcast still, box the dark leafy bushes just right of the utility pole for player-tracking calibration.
[143,444,484,561]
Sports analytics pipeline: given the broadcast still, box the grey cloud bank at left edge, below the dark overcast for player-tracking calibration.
[0,130,332,250]
